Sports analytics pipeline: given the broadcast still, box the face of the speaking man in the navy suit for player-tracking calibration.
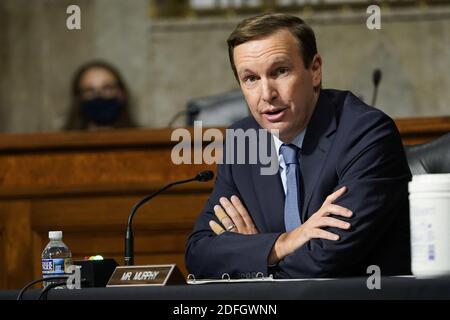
[233,29,322,142]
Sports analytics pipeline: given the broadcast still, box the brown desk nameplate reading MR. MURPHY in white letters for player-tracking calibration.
[106,264,186,287]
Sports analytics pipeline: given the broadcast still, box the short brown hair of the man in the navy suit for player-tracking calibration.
[227,13,317,82]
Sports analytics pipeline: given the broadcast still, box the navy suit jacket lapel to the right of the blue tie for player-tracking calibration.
[300,90,336,222]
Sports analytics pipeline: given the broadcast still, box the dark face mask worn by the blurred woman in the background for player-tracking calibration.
[81,97,123,126]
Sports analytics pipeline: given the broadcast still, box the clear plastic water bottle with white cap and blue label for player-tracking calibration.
[42,231,72,288]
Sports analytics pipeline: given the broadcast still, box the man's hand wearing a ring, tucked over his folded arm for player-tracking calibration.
[209,196,258,235]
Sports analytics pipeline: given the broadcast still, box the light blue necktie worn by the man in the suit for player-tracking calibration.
[280,144,301,231]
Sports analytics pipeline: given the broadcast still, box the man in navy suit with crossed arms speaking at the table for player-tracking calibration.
[186,14,411,278]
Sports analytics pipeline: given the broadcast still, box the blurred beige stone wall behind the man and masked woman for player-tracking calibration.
[0,0,450,133]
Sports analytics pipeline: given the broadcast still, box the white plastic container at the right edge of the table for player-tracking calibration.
[409,174,450,278]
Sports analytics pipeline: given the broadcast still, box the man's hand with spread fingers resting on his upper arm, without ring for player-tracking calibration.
[269,187,353,264]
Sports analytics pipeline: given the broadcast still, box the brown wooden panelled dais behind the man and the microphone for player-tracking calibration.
[0,117,450,289]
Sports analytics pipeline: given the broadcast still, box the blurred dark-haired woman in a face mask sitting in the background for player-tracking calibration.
[64,61,136,130]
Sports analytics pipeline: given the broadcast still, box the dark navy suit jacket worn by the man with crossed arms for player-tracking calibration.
[186,90,411,278]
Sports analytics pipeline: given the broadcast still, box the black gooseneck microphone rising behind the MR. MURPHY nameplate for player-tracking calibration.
[125,170,214,266]
